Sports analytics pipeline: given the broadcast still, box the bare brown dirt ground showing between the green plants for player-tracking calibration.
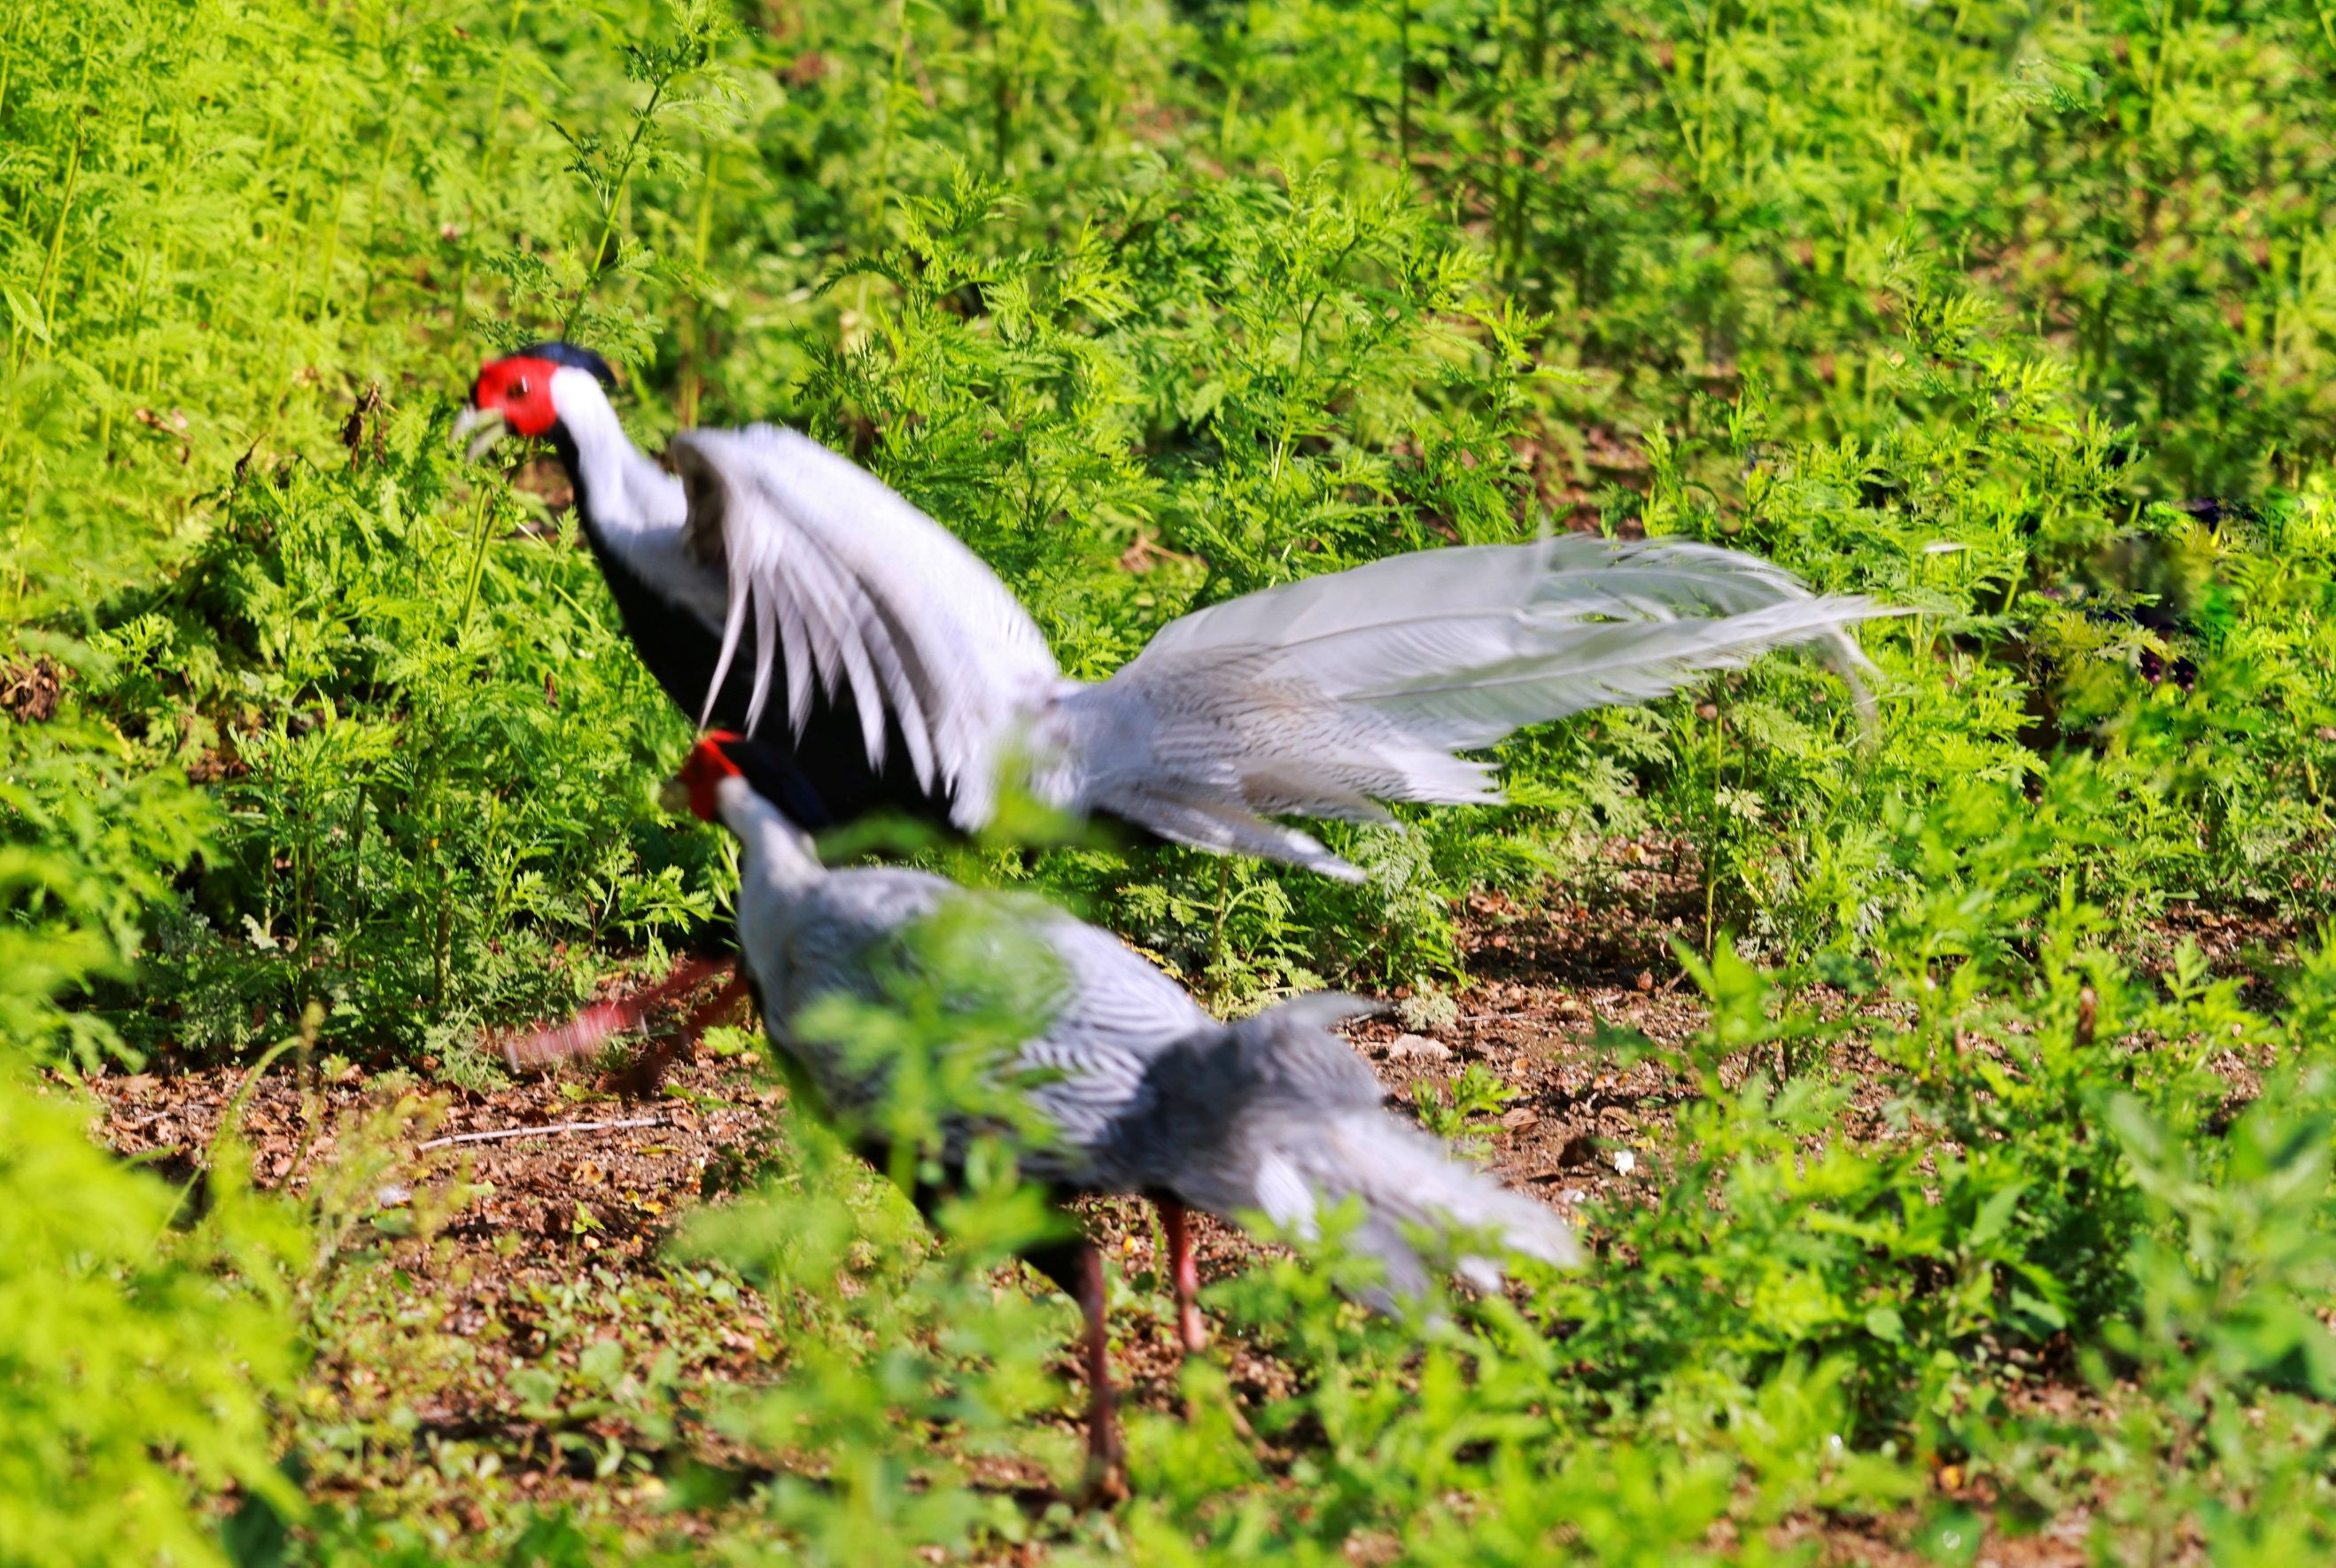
[91,846,2292,1568]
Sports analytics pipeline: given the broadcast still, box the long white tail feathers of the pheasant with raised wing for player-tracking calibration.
[1042,535,1890,876]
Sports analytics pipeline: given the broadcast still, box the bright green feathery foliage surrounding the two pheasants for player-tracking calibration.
[13,0,2336,1564]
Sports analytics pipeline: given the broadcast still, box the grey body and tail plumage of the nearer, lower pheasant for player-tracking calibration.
[718,778,1577,1304]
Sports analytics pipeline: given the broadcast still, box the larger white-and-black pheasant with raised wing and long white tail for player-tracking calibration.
[458,344,1890,879]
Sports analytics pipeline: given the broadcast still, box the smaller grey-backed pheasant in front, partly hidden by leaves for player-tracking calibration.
[668,732,1579,1484]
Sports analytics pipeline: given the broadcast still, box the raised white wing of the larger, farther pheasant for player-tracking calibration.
[671,425,1060,827]
